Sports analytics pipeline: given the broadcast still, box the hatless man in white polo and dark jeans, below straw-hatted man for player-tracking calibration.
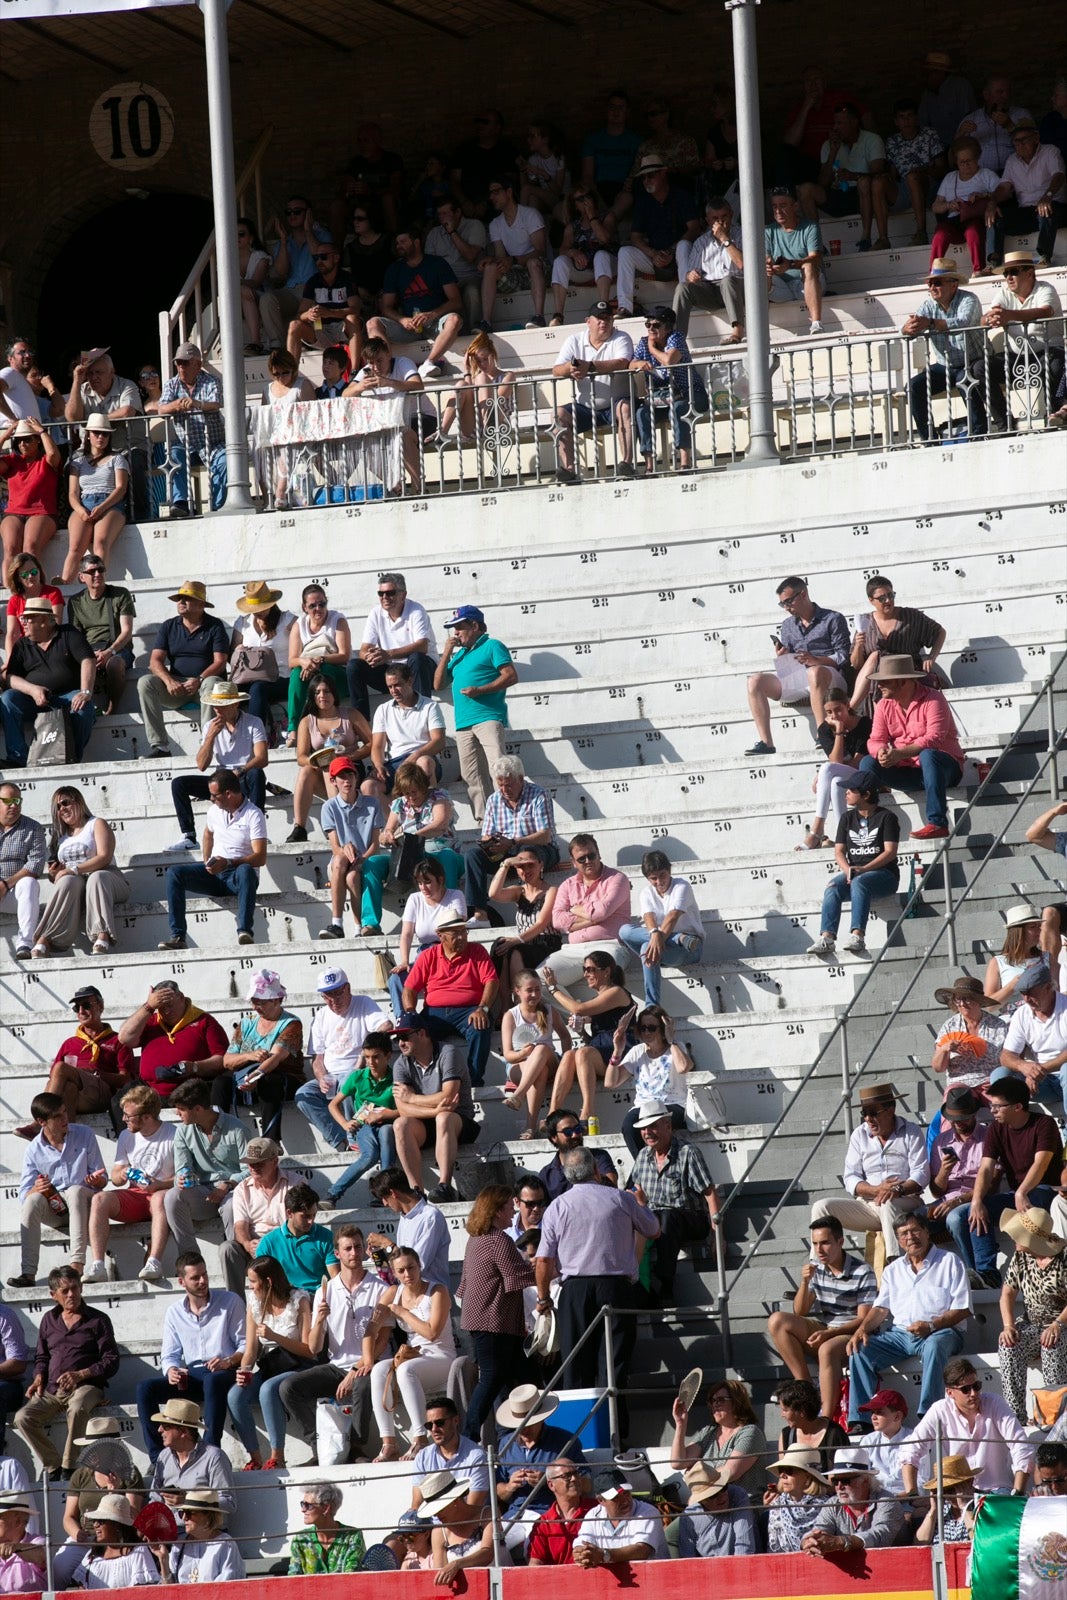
[158,766,267,950]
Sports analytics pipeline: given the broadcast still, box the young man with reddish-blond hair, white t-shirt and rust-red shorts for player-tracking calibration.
[82,1083,174,1283]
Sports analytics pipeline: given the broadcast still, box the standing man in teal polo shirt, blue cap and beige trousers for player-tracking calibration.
[434,605,518,822]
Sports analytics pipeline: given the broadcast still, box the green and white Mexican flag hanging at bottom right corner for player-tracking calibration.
[971,1494,1067,1600]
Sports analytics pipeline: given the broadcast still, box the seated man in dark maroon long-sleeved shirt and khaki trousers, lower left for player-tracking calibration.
[14,1266,118,1472]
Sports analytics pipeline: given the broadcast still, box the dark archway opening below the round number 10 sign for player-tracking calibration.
[37,194,213,380]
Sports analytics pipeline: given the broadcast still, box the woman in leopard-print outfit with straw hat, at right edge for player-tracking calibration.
[1000,1206,1067,1424]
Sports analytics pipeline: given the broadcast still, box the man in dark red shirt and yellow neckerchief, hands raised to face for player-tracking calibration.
[118,978,234,1110]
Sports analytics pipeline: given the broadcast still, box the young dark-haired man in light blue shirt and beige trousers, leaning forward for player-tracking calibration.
[8,1094,107,1288]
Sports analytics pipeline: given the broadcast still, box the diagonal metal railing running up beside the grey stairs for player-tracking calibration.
[712,653,1067,1355]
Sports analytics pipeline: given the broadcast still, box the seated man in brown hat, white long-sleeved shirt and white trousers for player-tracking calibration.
[811,1083,929,1260]
